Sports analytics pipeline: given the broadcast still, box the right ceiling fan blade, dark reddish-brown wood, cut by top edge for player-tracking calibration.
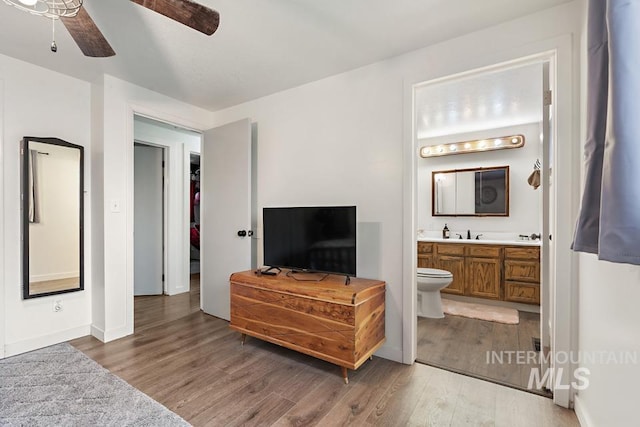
[131,0,220,36]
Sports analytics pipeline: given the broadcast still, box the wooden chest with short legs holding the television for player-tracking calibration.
[230,270,385,382]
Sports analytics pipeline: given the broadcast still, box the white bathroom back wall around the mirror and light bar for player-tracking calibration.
[417,123,542,239]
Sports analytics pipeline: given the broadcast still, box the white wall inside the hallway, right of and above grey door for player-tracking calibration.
[134,116,201,295]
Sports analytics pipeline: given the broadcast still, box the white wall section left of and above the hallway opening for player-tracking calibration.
[92,75,212,341]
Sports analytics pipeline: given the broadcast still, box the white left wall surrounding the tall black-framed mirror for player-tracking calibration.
[0,55,91,356]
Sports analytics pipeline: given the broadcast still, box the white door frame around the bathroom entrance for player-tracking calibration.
[402,35,580,407]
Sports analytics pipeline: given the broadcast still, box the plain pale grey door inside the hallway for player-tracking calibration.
[134,143,165,296]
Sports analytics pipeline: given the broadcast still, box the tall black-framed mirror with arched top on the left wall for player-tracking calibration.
[20,137,84,299]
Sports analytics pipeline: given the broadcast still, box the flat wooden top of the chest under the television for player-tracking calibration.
[230,270,385,305]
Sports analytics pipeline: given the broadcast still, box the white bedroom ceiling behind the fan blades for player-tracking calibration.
[0,0,570,111]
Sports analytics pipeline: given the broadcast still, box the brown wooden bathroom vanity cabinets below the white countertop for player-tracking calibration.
[418,239,540,305]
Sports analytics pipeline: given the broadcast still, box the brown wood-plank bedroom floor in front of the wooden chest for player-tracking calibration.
[71,276,579,426]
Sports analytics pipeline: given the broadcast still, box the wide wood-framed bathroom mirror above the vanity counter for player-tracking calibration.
[431,166,509,216]
